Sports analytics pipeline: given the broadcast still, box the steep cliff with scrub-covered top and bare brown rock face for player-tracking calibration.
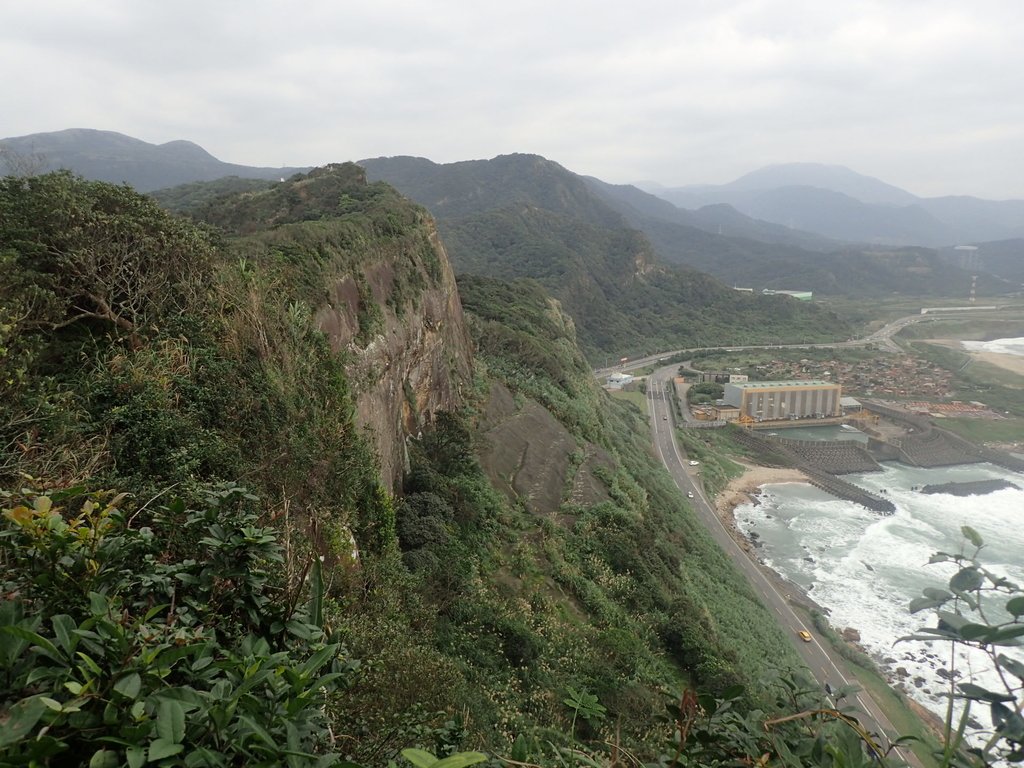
[186,163,472,488]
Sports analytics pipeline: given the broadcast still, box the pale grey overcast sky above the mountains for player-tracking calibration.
[0,0,1024,198]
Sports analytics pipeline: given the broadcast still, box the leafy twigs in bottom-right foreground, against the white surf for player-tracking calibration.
[900,525,1024,766]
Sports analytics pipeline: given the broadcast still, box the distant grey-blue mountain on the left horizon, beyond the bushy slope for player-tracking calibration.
[0,128,308,191]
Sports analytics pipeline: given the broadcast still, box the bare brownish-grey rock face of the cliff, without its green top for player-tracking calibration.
[315,214,472,487]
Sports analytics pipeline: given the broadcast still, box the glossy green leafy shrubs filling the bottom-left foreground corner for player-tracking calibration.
[0,485,355,768]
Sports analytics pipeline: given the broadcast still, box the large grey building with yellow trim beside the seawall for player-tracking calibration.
[722,380,841,421]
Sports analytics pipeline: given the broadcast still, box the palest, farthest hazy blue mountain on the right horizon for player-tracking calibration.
[645,163,1024,247]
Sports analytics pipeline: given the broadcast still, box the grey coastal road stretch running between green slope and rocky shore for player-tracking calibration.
[647,365,920,766]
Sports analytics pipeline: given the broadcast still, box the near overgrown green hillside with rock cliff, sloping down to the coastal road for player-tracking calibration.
[0,165,897,768]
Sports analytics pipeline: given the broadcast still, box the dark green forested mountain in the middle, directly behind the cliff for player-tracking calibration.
[361,155,845,362]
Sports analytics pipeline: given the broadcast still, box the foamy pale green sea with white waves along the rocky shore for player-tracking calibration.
[735,463,1024,739]
